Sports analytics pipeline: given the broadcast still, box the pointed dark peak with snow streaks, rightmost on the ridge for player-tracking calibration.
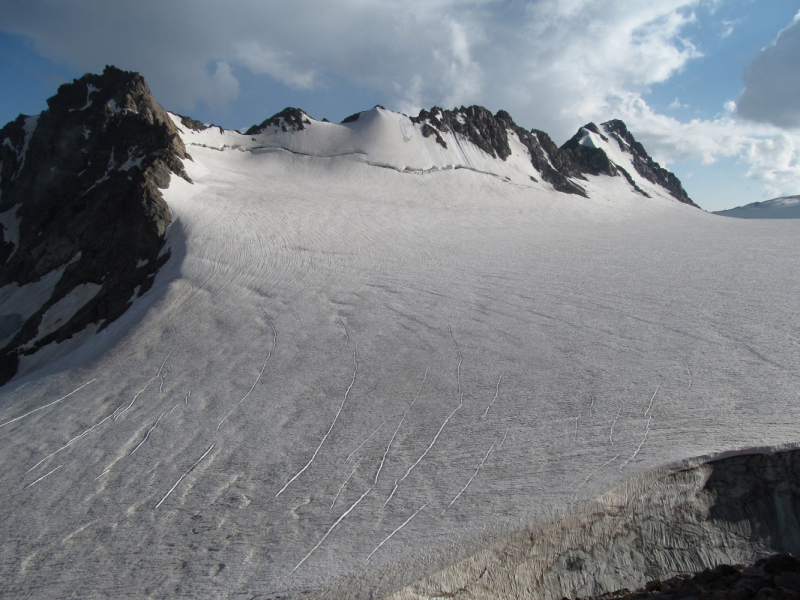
[561,119,699,208]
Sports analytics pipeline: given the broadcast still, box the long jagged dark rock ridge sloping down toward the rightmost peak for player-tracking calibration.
[411,106,586,196]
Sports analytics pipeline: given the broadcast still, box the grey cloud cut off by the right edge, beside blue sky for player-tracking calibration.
[736,12,800,128]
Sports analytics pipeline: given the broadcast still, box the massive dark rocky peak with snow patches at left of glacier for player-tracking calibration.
[0,67,189,384]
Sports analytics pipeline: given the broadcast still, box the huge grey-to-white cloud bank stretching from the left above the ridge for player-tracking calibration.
[0,0,699,138]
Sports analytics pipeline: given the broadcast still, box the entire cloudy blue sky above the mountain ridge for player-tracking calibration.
[0,0,800,210]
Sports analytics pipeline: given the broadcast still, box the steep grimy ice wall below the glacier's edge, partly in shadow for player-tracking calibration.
[387,450,800,600]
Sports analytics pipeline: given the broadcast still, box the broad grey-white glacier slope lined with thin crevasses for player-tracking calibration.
[0,115,800,598]
